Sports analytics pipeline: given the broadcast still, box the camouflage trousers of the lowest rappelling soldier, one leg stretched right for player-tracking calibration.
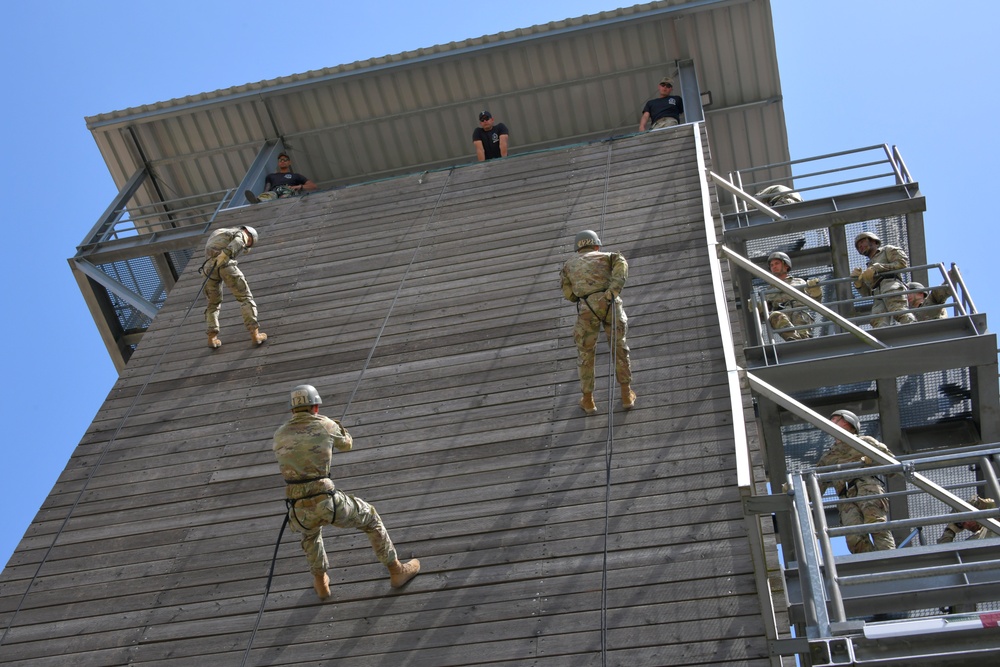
[288,490,396,574]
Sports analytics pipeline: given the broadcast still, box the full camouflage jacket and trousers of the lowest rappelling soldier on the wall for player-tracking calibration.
[274,412,396,575]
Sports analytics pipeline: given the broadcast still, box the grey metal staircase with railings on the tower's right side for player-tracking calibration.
[710,146,1000,666]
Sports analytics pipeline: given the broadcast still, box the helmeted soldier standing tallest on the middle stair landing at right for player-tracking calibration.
[851,232,916,327]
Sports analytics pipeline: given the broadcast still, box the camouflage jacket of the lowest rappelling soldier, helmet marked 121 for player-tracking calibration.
[274,412,354,498]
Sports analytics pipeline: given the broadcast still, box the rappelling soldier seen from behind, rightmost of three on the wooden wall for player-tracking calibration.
[562,230,635,415]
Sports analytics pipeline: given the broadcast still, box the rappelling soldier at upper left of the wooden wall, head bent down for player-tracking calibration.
[202,225,267,348]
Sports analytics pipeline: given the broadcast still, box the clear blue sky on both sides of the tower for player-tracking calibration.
[0,0,1000,563]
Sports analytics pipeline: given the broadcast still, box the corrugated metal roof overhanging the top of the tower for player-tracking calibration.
[87,0,788,218]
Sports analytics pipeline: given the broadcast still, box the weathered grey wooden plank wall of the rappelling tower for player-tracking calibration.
[0,126,770,667]
